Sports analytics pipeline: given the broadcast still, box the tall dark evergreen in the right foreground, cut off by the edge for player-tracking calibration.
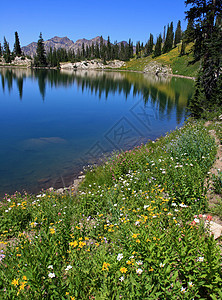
[185,0,222,117]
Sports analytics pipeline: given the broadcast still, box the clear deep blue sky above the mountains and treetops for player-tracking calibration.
[0,0,186,48]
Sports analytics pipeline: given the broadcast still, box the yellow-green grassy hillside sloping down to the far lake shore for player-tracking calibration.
[121,44,200,77]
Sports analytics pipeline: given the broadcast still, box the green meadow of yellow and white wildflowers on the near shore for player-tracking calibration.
[0,122,222,300]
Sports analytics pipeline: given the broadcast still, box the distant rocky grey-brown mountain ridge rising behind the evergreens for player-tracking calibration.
[22,36,127,57]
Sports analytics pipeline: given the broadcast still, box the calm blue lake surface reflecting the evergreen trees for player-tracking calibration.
[0,68,193,195]
